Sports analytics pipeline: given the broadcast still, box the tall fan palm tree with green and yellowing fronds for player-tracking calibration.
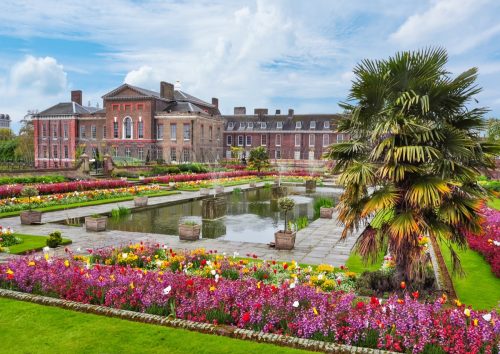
[326,48,500,280]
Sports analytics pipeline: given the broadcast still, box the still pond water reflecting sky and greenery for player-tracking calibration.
[108,187,340,243]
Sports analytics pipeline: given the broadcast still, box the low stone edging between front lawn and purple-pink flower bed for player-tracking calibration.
[0,289,393,354]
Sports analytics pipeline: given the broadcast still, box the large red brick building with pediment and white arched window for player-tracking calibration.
[33,82,223,168]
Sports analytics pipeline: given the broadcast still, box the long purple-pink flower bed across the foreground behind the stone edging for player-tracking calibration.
[0,257,500,353]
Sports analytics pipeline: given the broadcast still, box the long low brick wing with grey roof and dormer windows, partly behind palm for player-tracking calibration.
[223,107,349,160]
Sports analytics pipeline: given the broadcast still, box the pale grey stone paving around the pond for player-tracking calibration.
[0,185,357,266]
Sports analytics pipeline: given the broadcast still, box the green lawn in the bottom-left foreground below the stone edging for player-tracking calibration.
[0,298,312,354]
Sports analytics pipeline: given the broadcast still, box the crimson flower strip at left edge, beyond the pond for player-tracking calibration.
[0,179,130,198]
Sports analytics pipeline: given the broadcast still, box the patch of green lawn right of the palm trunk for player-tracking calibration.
[441,246,500,309]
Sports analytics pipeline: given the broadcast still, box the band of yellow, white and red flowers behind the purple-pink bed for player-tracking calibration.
[75,243,356,291]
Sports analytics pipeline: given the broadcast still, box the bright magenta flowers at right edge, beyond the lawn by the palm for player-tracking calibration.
[466,208,500,278]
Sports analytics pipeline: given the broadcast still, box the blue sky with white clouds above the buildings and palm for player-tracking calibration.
[0,0,500,131]
